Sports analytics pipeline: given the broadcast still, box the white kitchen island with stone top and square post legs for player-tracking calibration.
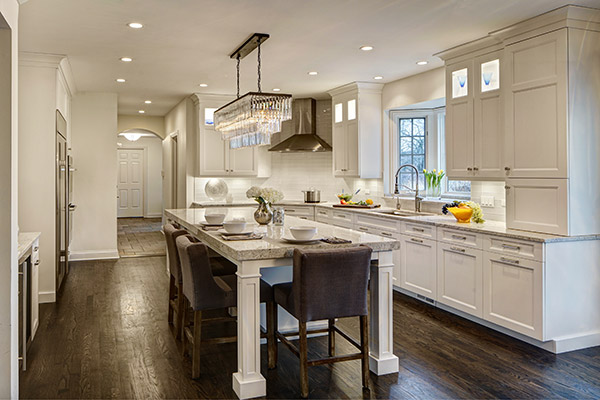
[165,207,400,398]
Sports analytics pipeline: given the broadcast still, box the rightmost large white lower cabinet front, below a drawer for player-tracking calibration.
[483,252,543,340]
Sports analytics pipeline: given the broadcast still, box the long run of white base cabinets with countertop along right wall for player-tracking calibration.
[315,205,600,353]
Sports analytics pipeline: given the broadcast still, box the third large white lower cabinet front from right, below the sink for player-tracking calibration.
[399,235,437,300]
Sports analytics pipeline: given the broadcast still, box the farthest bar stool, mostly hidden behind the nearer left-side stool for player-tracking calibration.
[163,224,237,340]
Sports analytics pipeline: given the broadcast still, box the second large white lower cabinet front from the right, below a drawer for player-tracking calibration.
[437,243,483,318]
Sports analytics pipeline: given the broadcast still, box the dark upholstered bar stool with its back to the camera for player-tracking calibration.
[269,246,372,398]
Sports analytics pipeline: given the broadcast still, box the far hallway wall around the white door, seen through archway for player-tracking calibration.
[115,136,162,218]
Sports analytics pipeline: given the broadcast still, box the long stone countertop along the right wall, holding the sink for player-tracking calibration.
[317,204,600,243]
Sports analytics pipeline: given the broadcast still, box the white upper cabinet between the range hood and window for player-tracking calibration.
[329,82,383,178]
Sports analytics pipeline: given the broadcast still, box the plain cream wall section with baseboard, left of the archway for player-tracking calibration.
[71,92,118,260]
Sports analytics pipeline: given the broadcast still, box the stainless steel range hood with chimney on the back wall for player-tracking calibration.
[269,98,331,153]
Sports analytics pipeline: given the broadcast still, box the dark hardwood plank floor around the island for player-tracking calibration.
[21,257,600,399]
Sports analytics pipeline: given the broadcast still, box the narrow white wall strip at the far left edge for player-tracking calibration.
[0,0,19,399]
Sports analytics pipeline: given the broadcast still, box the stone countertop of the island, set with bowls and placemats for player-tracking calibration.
[165,207,400,261]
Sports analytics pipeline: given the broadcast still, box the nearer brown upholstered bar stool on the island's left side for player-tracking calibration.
[176,235,277,379]
